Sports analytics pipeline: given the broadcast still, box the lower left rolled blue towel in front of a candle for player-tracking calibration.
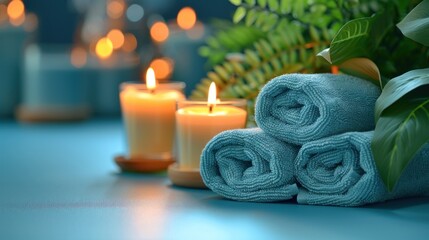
[200,128,298,202]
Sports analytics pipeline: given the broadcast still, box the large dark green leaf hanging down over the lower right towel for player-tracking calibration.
[371,95,429,191]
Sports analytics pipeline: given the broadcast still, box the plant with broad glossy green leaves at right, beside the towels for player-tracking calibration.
[320,0,429,191]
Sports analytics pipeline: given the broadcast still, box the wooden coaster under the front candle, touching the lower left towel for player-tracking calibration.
[168,163,207,188]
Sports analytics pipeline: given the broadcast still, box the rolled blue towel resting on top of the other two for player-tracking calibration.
[255,74,380,145]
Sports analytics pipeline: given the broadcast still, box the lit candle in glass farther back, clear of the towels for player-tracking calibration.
[120,68,185,159]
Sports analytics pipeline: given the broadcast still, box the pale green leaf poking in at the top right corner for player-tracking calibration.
[397,0,429,46]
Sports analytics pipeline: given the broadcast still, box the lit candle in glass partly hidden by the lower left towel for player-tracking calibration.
[176,83,246,170]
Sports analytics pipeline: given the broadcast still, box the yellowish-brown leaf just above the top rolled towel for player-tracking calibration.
[339,58,382,88]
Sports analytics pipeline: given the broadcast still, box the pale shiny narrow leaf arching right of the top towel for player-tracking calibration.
[375,68,429,121]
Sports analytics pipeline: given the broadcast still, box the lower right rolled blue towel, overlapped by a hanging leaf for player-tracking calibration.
[295,132,429,206]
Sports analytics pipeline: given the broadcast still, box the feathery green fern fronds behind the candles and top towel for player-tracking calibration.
[191,0,400,125]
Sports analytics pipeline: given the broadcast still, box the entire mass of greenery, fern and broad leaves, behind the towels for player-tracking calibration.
[191,0,429,190]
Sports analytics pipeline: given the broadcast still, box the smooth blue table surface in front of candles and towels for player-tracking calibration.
[0,119,429,240]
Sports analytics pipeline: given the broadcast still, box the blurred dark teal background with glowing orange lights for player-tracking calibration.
[0,0,235,121]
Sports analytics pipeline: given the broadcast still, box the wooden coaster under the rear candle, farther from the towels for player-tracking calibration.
[115,156,174,173]
